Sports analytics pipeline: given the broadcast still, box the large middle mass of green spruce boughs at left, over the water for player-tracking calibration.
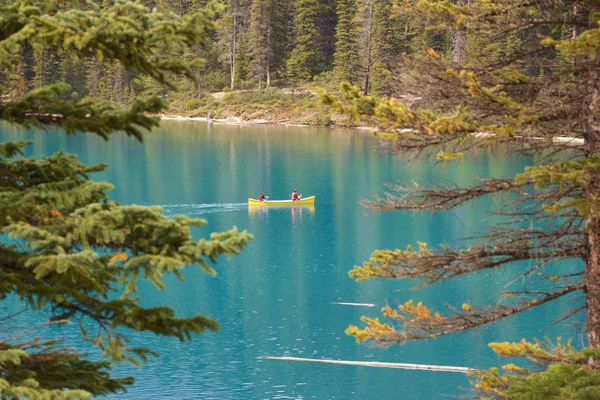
[0,139,251,394]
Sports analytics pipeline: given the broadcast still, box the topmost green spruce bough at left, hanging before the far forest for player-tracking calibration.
[0,0,217,85]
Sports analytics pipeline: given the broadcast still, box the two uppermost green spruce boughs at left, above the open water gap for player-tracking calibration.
[0,0,224,134]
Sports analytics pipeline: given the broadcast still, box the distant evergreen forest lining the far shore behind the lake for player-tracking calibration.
[0,0,453,104]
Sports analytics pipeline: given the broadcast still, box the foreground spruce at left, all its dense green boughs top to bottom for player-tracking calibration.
[0,0,251,399]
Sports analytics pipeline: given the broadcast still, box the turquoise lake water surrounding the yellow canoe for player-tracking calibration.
[0,122,581,399]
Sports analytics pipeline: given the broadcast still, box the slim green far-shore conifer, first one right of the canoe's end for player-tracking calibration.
[333,0,360,85]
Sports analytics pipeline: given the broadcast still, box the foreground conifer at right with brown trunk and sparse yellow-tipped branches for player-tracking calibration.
[321,0,600,399]
